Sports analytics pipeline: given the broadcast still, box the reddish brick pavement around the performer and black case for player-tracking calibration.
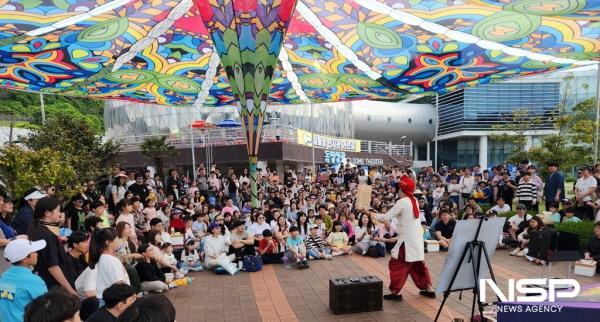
[167,250,600,322]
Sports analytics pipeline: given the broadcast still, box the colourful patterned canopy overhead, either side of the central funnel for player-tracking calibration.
[0,0,600,106]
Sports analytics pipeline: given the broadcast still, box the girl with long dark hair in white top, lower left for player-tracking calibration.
[90,228,130,299]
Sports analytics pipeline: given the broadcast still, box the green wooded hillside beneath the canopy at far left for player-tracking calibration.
[0,89,104,134]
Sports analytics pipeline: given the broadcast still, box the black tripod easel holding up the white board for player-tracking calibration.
[435,216,496,322]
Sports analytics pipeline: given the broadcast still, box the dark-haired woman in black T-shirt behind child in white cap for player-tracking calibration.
[29,197,77,295]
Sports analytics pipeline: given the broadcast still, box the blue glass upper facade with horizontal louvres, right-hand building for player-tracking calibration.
[438,82,560,135]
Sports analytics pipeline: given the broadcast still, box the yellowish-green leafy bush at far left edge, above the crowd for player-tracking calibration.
[0,145,77,197]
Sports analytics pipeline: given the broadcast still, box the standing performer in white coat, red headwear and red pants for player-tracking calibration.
[376,175,435,301]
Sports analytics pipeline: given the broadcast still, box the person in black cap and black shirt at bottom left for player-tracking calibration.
[86,284,136,322]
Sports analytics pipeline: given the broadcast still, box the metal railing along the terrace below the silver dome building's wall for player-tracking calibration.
[112,125,412,158]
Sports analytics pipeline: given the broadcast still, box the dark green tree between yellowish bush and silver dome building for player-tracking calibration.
[21,113,121,180]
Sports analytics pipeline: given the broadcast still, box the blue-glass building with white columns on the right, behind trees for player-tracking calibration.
[424,66,598,168]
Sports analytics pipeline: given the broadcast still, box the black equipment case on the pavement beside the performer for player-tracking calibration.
[329,276,383,314]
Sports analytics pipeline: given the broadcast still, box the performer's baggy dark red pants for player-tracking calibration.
[389,244,432,294]
